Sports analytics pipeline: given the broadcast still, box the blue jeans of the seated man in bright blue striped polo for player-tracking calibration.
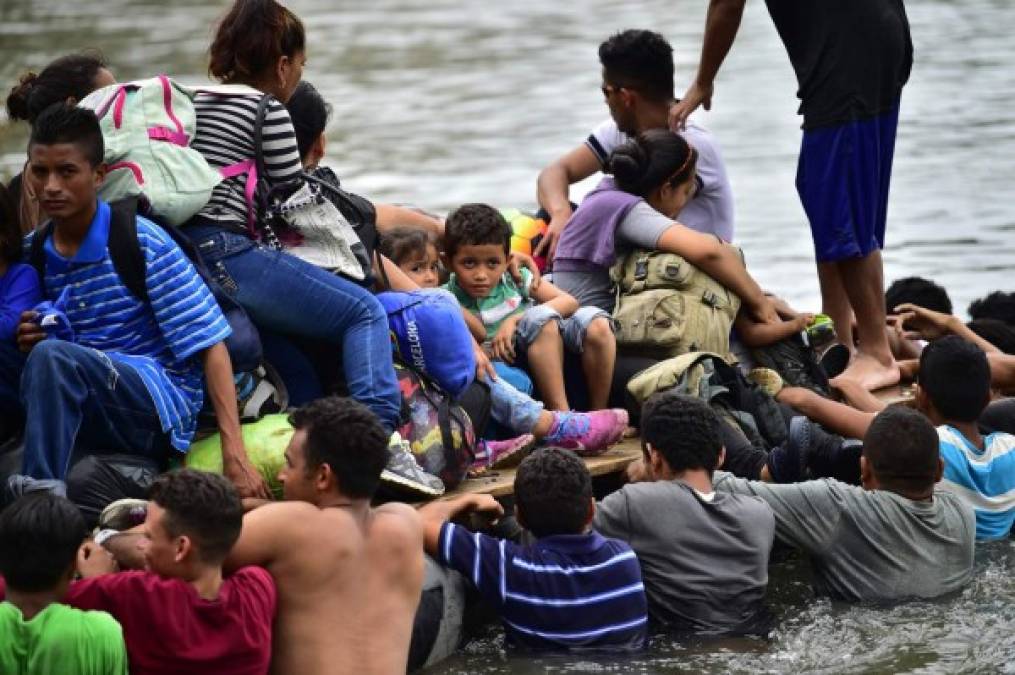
[0,338,170,480]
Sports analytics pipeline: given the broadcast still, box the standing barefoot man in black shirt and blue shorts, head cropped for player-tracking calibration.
[670,0,912,390]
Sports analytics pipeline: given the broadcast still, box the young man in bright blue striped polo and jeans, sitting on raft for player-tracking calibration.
[0,106,267,496]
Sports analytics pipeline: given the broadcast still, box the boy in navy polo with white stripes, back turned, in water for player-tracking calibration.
[419,448,648,650]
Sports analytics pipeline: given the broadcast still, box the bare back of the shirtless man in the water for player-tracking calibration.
[234,501,423,675]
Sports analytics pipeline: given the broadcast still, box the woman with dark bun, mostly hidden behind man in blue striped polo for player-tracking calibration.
[7,52,116,234]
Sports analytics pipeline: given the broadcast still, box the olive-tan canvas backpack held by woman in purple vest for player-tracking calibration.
[610,250,740,360]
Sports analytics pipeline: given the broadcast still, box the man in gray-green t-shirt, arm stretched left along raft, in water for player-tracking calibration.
[714,406,975,601]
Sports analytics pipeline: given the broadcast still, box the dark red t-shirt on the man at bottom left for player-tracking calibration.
[63,567,275,675]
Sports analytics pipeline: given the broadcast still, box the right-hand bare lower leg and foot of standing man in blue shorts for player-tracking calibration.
[836,251,899,391]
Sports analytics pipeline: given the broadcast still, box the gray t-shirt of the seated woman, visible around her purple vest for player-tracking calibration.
[552,201,674,314]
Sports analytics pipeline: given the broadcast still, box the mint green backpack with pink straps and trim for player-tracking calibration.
[79,75,223,225]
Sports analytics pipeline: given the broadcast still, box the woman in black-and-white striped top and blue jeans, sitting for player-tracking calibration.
[187,0,401,432]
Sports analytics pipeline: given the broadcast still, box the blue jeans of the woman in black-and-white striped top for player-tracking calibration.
[185,221,402,431]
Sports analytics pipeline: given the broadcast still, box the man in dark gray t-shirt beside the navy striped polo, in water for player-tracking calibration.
[593,393,774,633]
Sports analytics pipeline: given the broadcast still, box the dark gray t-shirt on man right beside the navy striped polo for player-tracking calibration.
[593,481,774,631]
